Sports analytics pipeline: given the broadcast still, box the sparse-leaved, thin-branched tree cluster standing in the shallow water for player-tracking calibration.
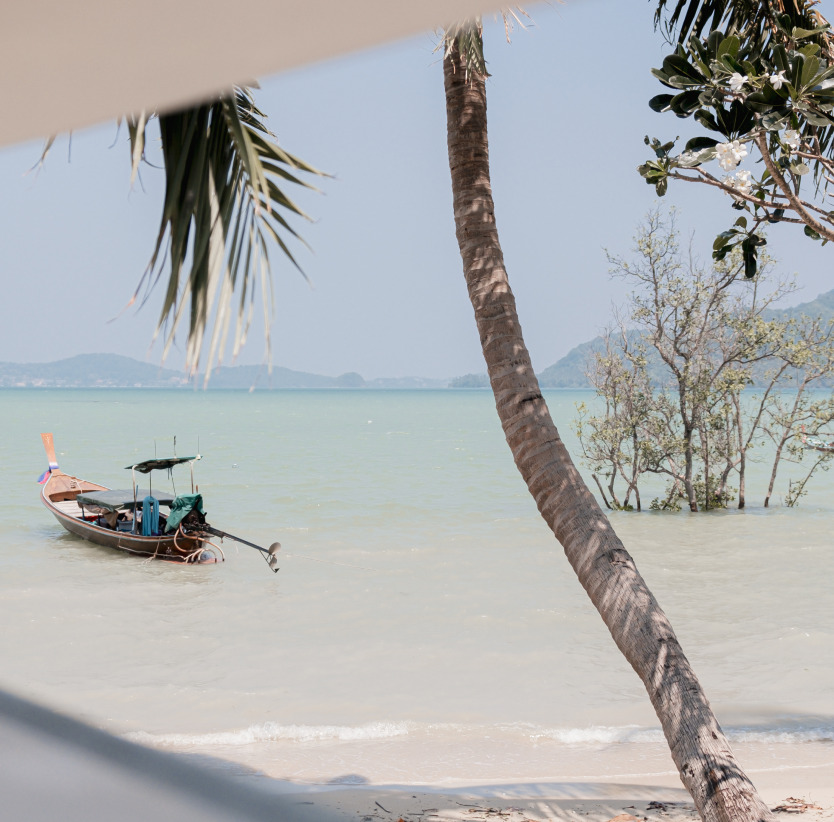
[576,210,834,511]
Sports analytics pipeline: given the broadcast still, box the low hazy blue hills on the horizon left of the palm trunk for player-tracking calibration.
[0,354,448,390]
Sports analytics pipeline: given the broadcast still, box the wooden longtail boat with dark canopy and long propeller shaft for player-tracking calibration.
[38,434,281,571]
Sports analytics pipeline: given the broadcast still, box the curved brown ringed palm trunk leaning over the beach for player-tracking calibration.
[444,35,771,822]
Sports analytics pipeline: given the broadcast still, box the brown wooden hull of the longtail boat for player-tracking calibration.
[41,469,218,565]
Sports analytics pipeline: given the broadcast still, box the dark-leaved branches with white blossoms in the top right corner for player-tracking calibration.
[638,0,834,277]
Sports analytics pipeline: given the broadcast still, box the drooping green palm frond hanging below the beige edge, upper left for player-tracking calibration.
[128,88,326,381]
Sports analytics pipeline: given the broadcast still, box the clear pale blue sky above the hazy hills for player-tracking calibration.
[0,0,834,379]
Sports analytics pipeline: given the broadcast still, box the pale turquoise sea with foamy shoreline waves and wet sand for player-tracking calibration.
[0,389,834,786]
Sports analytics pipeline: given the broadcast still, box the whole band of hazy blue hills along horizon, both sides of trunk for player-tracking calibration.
[8,289,834,391]
